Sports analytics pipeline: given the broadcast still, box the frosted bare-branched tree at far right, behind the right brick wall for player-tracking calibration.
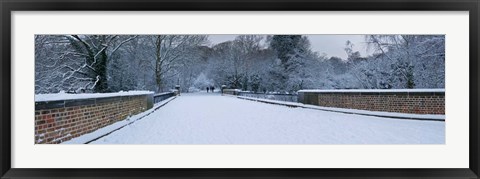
[366,35,445,88]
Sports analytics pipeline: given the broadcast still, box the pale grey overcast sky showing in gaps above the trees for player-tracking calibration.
[210,35,370,59]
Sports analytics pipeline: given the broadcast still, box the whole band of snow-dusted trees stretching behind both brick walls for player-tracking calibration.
[35,35,445,94]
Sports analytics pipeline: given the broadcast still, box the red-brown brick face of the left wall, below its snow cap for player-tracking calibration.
[35,95,148,144]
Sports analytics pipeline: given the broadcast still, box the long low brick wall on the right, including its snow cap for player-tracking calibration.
[298,89,445,114]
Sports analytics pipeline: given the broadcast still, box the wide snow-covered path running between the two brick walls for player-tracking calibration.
[92,93,445,144]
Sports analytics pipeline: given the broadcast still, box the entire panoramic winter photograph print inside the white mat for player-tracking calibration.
[32,34,446,145]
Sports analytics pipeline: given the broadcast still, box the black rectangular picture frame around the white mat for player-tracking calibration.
[0,0,480,178]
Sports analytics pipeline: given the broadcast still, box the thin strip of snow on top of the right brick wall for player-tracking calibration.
[298,89,445,93]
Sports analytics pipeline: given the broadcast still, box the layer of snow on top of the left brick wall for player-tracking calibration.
[35,91,153,102]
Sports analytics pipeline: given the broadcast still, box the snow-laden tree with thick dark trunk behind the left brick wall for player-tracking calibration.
[36,35,136,92]
